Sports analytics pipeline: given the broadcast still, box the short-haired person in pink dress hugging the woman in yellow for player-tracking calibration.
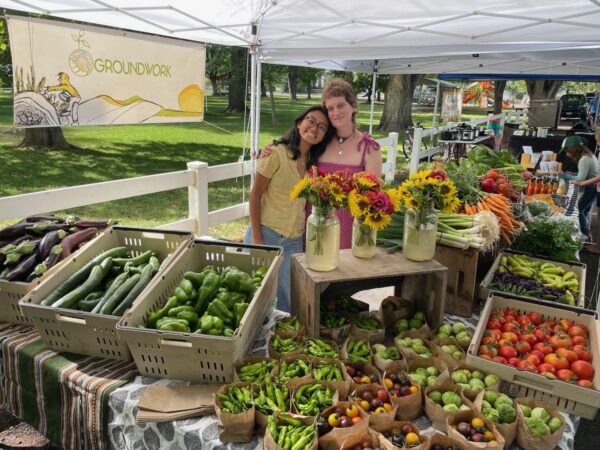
[259,78,382,249]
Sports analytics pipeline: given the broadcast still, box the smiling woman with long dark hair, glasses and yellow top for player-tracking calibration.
[245,106,332,312]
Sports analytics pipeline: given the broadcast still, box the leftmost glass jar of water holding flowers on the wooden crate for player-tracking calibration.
[306,206,340,272]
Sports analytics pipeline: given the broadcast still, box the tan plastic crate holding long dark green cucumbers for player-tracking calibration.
[19,227,192,360]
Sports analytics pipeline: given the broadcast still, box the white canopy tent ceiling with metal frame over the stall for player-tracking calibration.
[0,0,600,74]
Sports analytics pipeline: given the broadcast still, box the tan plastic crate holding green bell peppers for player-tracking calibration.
[117,240,282,383]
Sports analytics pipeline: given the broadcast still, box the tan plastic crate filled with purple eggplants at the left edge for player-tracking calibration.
[0,230,106,325]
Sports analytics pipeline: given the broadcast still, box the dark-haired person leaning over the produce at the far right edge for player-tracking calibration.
[560,145,598,240]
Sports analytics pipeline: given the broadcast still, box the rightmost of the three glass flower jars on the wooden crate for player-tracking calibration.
[402,209,438,261]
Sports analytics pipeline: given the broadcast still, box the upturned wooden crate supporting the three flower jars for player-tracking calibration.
[291,248,448,336]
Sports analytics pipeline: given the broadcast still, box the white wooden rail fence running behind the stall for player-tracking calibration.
[0,114,524,236]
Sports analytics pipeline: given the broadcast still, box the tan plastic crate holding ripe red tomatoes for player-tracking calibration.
[466,294,600,419]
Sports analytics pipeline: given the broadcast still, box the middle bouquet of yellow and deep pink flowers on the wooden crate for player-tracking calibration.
[347,172,401,246]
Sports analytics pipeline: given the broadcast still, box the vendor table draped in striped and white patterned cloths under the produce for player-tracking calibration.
[0,311,579,450]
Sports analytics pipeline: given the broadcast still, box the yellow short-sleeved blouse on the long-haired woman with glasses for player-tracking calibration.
[256,145,306,237]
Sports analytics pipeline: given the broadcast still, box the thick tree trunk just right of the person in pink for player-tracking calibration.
[377,75,421,133]
